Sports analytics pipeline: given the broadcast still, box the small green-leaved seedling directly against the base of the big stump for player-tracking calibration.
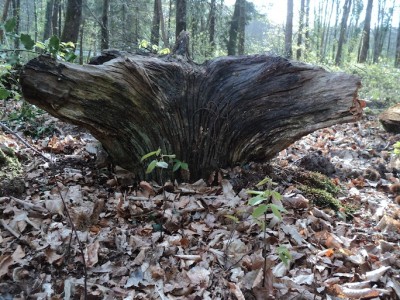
[140,148,189,174]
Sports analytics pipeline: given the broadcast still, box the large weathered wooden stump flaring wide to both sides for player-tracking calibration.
[21,36,362,180]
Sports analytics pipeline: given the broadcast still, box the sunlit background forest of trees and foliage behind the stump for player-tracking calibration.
[0,0,400,106]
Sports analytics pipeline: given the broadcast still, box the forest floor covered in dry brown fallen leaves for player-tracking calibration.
[0,108,400,300]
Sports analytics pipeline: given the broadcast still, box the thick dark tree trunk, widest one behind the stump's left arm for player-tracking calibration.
[61,0,82,44]
